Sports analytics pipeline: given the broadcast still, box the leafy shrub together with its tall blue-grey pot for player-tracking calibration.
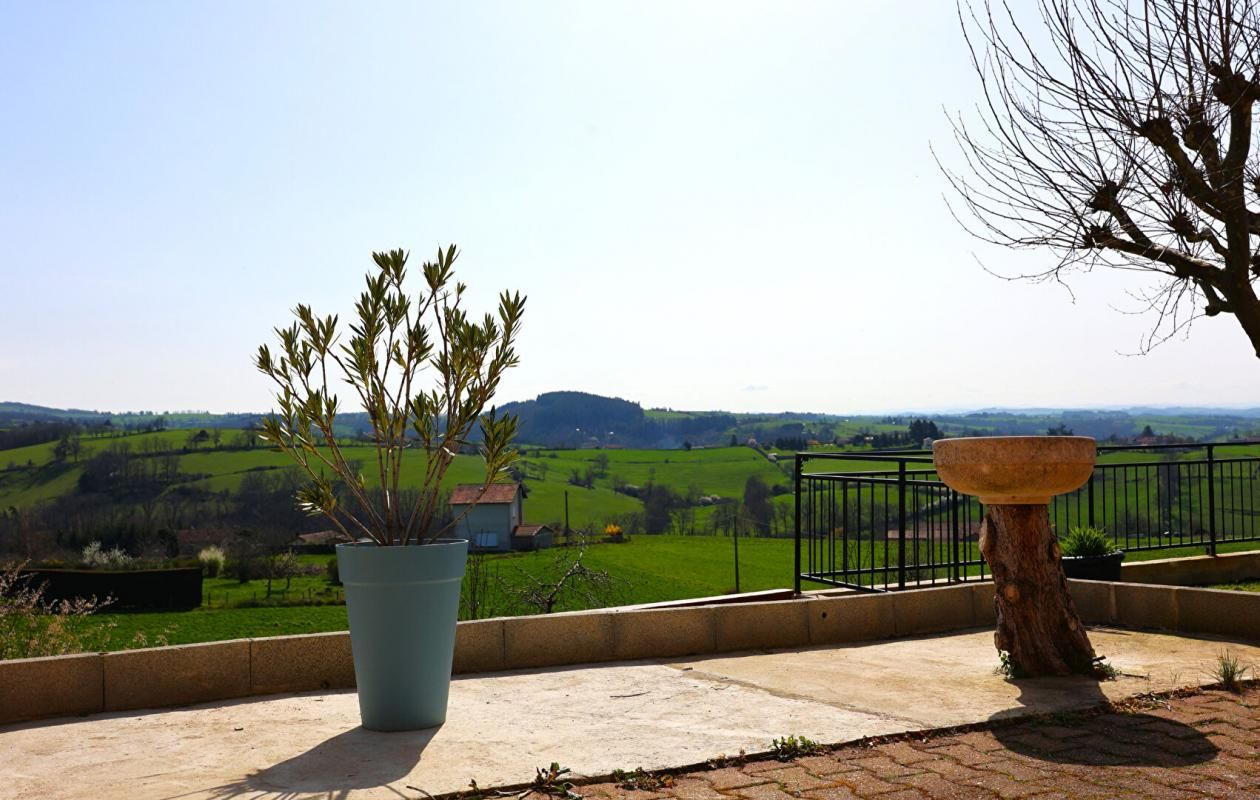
[255,246,525,731]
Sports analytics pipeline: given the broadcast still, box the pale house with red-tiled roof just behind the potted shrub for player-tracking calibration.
[451,484,554,552]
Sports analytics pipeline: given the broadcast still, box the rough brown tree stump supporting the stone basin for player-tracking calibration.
[980,505,1094,677]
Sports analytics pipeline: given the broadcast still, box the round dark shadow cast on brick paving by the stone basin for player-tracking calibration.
[990,678,1220,767]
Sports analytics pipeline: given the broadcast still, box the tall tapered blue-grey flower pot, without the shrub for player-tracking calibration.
[336,539,467,731]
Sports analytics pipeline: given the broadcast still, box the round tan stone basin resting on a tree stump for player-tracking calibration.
[932,436,1097,505]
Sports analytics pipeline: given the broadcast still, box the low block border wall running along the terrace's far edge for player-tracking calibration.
[0,554,1260,724]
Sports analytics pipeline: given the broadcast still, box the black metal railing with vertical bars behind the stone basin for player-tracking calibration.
[795,441,1260,592]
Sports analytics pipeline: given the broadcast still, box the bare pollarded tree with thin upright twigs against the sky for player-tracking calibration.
[942,0,1260,355]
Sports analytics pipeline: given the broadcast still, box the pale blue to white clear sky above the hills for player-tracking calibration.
[0,0,1260,412]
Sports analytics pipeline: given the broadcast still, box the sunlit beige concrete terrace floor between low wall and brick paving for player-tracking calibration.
[0,629,1260,800]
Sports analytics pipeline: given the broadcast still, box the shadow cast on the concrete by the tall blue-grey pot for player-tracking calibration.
[194,727,441,800]
